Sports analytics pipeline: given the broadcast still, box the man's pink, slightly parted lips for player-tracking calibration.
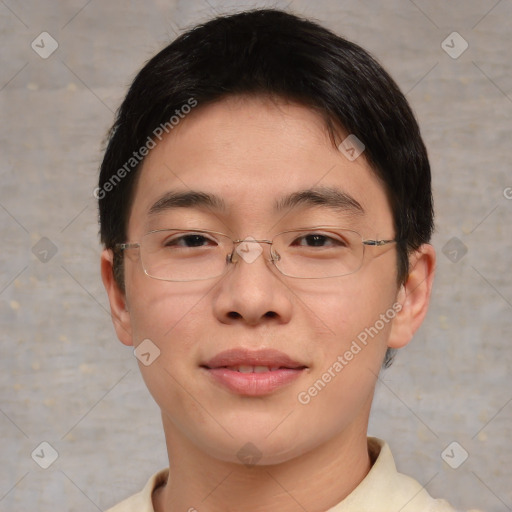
[201,348,307,396]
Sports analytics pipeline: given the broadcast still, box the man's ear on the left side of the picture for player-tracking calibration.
[101,249,133,345]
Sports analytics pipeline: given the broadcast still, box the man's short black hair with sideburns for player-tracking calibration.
[96,9,434,366]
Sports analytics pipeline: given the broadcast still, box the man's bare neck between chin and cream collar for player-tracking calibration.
[153,417,371,512]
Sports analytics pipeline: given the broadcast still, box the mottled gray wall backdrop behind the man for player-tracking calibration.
[0,0,512,512]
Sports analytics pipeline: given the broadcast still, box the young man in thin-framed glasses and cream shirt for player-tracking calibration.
[96,10,472,512]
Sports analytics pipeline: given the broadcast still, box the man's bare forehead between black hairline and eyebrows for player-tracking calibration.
[128,97,392,235]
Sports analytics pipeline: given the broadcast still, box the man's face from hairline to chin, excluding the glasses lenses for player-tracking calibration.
[104,98,412,463]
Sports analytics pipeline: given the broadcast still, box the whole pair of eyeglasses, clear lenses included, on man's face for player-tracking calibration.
[115,226,397,281]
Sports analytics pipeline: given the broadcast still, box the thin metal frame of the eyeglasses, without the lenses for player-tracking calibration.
[114,226,400,283]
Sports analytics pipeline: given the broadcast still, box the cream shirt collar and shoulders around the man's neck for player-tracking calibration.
[107,437,472,512]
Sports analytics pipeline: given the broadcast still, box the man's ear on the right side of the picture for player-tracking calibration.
[388,244,436,348]
